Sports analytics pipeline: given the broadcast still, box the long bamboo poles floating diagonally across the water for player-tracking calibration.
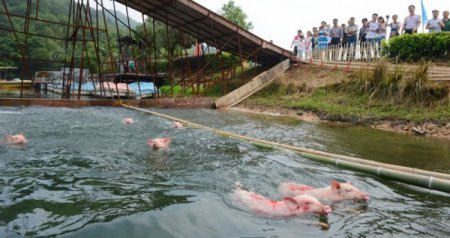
[123,105,450,193]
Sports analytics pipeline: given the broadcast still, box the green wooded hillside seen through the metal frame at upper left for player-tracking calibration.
[0,0,139,72]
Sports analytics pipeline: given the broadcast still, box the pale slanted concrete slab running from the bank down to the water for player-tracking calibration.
[215,59,291,108]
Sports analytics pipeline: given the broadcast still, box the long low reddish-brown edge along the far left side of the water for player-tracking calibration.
[0,97,214,109]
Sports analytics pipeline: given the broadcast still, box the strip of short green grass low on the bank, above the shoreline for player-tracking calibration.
[247,88,450,124]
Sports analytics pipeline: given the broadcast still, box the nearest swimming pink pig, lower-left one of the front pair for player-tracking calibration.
[231,188,331,217]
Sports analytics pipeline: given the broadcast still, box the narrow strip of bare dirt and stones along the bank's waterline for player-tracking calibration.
[226,106,450,140]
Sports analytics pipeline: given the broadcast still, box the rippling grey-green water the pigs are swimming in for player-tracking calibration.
[0,107,450,237]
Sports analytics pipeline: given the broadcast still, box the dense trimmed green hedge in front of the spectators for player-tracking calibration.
[383,32,450,61]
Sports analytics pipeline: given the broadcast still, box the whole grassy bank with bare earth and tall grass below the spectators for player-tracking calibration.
[243,64,450,125]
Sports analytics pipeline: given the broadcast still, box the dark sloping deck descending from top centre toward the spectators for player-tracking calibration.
[116,0,293,67]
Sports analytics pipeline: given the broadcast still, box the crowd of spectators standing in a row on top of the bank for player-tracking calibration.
[291,5,450,57]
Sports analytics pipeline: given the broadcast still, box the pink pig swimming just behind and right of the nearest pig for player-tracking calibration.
[278,180,369,201]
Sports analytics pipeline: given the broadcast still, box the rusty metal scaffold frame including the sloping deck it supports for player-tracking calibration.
[0,0,291,100]
